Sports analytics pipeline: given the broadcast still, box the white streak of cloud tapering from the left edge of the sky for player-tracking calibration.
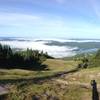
[0,13,41,26]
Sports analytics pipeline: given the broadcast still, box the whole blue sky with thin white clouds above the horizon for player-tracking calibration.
[0,0,100,38]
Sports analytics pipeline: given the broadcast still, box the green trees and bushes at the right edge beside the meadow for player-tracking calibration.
[74,49,100,68]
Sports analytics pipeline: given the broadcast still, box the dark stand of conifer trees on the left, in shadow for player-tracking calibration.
[0,44,53,70]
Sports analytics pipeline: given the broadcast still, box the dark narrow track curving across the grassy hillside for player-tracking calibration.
[0,68,78,84]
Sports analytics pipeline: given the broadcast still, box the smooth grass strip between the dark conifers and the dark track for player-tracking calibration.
[0,59,77,79]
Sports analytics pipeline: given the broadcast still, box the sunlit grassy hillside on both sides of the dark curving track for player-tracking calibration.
[0,59,100,100]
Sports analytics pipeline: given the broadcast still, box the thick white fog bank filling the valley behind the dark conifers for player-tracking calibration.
[0,40,75,58]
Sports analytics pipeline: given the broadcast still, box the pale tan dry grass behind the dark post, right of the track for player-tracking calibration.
[60,67,100,84]
